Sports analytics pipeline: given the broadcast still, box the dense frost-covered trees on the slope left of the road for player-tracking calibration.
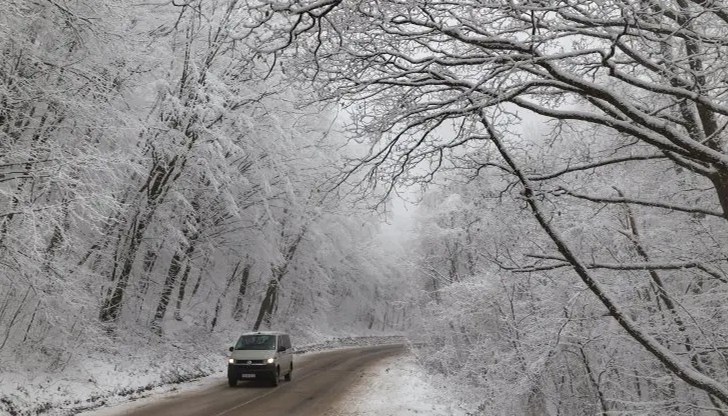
[0,0,410,413]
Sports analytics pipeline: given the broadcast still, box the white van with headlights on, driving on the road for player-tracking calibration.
[228,331,293,387]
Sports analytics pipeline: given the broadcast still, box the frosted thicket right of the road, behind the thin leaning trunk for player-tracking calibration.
[416,135,728,415]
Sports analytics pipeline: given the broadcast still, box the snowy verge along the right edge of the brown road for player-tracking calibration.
[324,353,467,416]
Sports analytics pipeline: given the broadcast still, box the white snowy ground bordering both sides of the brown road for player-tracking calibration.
[0,335,464,416]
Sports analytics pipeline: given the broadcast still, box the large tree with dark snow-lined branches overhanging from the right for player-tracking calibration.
[253,0,728,413]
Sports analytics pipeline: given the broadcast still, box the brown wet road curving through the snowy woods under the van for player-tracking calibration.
[92,345,404,416]
